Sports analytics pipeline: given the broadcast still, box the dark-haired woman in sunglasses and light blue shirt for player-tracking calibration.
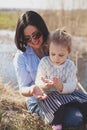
[14,11,49,117]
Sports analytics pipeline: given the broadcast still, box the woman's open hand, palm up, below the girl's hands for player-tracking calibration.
[33,86,47,100]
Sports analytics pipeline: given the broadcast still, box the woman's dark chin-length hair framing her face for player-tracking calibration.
[15,11,49,52]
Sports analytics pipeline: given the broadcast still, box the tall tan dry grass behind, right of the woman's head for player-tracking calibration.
[40,10,87,36]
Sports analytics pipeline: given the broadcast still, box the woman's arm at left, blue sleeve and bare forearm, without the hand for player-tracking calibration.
[13,53,35,97]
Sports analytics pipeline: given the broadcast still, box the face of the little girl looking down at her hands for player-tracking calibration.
[49,42,69,65]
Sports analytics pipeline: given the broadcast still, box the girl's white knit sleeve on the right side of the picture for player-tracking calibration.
[62,62,77,94]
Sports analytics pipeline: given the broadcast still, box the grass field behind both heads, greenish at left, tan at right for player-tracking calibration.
[0,10,87,36]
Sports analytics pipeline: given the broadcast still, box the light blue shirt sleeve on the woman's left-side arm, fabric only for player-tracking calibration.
[13,54,32,89]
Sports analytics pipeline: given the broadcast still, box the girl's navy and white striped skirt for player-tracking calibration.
[38,90,87,124]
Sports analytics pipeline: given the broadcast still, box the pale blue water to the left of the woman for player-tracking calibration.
[0,30,17,86]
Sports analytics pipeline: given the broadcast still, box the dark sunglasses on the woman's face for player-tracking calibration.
[24,31,42,43]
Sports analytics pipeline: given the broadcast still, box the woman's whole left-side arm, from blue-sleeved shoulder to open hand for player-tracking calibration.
[14,51,46,99]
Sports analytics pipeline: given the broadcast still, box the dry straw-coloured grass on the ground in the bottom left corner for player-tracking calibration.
[0,83,51,130]
